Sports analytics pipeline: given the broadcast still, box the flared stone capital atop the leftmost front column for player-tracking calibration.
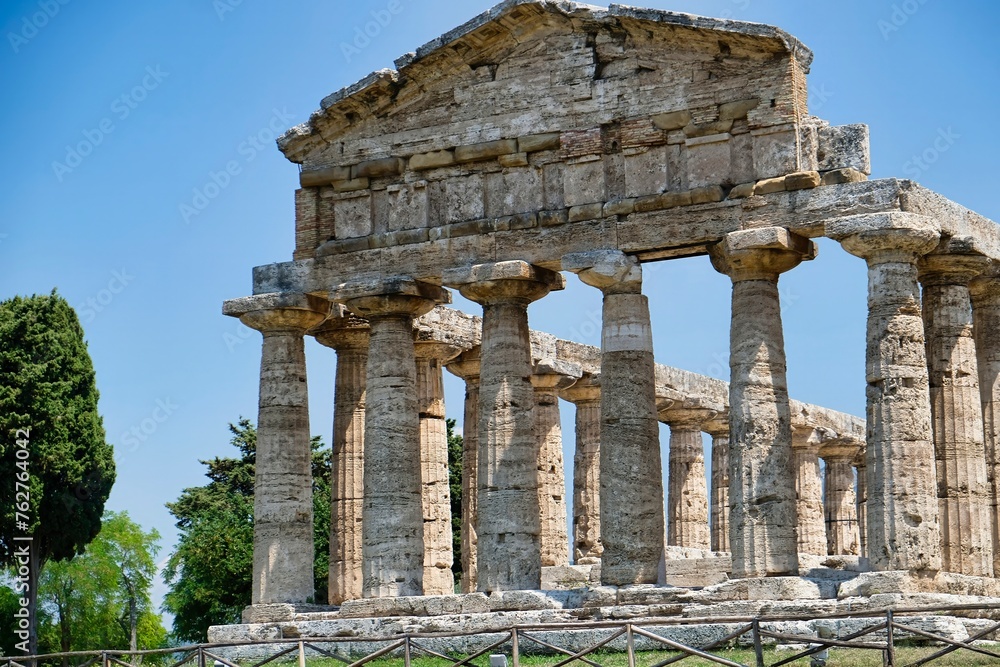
[222,292,331,335]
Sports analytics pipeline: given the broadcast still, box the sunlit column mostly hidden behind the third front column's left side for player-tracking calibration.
[448,346,480,593]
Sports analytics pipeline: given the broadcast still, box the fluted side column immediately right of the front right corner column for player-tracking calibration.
[920,241,993,577]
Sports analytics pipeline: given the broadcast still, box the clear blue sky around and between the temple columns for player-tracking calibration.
[0,0,1000,616]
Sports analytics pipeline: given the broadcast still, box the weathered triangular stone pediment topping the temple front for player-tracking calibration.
[279,0,812,170]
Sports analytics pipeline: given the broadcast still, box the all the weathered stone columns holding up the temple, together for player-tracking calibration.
[234,223,1000,603]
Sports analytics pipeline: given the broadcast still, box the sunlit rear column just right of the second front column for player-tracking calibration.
[414,341,462,595]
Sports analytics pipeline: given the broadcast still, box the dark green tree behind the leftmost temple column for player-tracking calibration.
[164,419,330,641]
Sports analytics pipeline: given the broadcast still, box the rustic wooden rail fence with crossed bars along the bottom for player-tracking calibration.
[0,604,1000,667]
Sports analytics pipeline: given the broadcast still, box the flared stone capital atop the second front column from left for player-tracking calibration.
[330,276,451,318]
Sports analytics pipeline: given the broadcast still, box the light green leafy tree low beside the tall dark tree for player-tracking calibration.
[39,512,166,665]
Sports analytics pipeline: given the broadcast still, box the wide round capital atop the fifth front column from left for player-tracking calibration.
[708,227,817,282]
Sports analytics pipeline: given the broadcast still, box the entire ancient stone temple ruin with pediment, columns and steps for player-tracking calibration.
[219,0,1000,640]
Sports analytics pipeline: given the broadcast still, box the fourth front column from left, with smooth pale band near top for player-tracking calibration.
[562,250,664,586]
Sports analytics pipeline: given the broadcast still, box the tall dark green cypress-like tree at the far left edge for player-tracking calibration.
[0,290,115,651]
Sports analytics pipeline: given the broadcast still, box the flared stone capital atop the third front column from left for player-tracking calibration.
[443,260,566,306]
